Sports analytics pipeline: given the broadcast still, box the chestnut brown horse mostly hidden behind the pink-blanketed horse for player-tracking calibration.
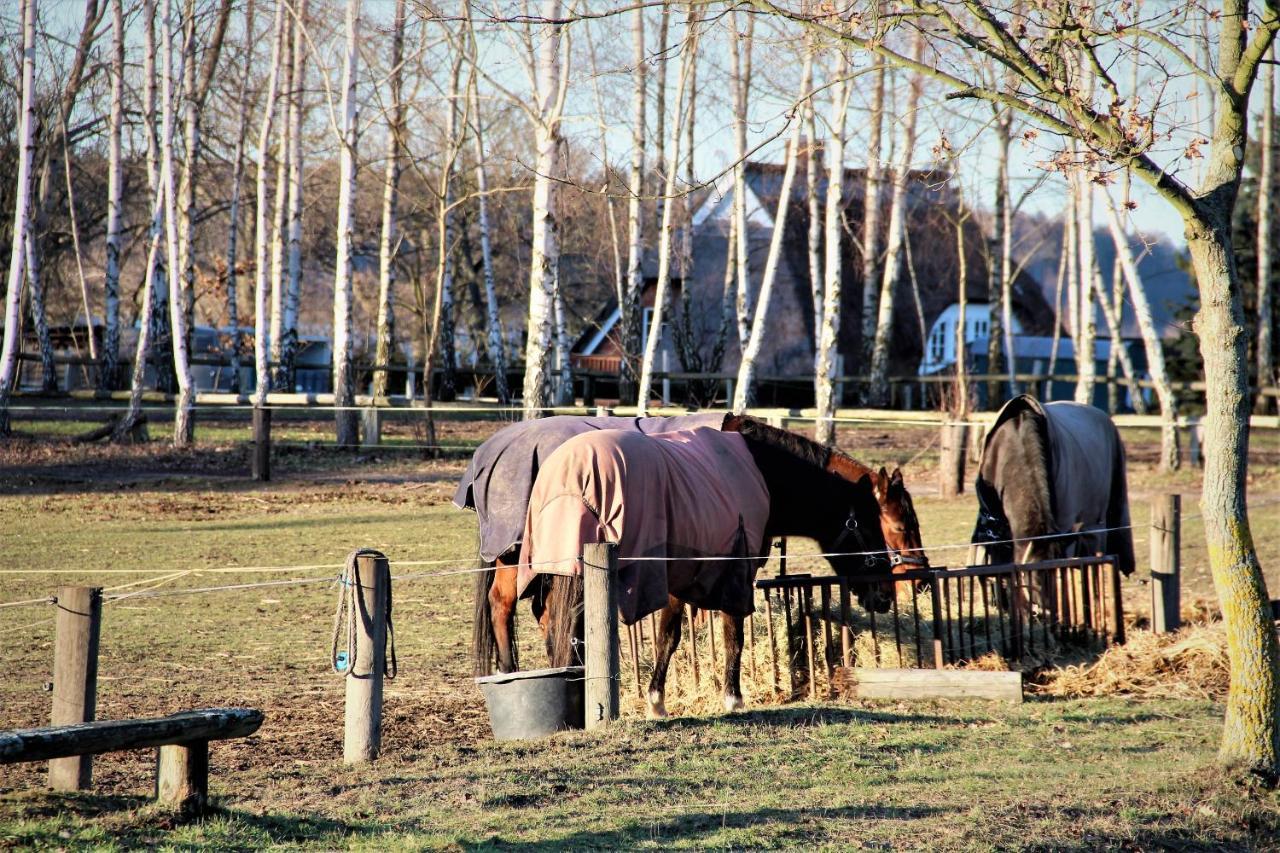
[471,415,928,675]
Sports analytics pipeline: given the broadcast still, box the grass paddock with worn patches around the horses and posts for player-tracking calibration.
[0,412,1280,849]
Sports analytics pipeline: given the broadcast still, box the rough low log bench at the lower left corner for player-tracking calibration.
[0,708,262,813]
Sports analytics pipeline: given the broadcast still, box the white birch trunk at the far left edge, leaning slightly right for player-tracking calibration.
[0,0,36,435]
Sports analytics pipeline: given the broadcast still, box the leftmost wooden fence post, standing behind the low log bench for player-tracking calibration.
[49,587,102,790]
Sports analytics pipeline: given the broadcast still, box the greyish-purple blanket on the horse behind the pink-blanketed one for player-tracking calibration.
[453,412,724,562]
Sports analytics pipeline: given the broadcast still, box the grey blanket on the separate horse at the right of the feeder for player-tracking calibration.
[973,394,1135,575]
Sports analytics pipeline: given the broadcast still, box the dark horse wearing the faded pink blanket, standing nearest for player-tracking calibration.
[517,427,888,716]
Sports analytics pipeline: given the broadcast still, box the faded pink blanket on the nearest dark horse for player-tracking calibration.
[518,428,769,625]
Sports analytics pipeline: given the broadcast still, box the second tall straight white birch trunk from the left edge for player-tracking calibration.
[98,0,124,391]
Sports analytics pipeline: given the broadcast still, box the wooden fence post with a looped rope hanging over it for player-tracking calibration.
[342,551,392,765]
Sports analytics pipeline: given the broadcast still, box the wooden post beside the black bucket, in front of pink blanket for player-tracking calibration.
[582,542,621,730]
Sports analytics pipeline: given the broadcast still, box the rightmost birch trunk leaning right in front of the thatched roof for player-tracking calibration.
[869,41,924,406]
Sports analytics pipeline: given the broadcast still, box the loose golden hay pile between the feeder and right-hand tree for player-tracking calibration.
[1033,622,1230,699]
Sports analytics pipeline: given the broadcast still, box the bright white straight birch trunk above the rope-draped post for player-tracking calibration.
[333,0,360,447]
